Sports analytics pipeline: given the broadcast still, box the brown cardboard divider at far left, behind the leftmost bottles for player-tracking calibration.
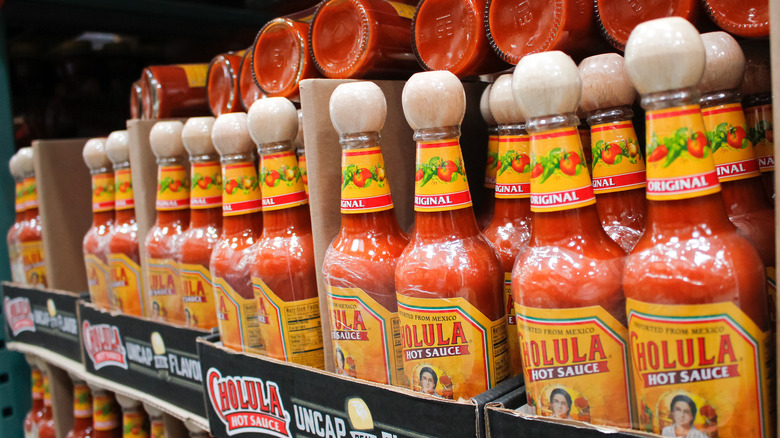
[32,138,92,291]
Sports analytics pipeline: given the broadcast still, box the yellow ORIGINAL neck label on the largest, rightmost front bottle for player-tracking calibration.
[646,105,720,201]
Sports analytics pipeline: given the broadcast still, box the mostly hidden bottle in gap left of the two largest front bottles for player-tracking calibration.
[482,74,531,375]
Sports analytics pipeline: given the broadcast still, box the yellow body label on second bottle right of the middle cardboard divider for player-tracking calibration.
[179,263,217,329]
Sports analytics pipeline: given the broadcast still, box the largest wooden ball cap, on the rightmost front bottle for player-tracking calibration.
[625,17,705,95]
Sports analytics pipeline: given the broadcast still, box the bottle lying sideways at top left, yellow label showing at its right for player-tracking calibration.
[141,64,209,119]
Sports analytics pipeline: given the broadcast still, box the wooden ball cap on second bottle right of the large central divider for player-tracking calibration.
[401,71,466,130]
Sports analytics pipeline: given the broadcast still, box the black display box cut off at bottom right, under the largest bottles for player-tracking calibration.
[485,387,659,438]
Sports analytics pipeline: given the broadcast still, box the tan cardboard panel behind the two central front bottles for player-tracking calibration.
[301,79,488,371]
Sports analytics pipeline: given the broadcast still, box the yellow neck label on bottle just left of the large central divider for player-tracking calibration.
[260,151,309,211]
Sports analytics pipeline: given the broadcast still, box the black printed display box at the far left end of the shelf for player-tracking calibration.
[3,282,81,363]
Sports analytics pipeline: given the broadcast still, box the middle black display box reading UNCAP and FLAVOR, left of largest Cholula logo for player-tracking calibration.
[79,302,210,418]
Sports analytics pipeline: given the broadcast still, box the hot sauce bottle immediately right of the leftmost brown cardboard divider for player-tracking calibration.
[82,138,115,309]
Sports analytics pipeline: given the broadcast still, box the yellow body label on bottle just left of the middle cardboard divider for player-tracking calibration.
[108,254,146,316]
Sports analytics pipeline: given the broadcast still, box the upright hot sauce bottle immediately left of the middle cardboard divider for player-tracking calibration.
[106,131,146,316]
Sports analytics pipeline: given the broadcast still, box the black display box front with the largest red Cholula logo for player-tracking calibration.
[198,335,522,438]
